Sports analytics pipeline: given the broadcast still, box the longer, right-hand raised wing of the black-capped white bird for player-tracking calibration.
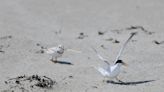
[114,32,137,63]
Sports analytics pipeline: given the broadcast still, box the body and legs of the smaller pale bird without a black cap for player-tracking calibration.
[46,45,64,63]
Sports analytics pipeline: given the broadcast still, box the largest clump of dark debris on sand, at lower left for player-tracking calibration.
[4,74,57,92]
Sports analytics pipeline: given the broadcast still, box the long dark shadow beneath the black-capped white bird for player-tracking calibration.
[106,80,155,85]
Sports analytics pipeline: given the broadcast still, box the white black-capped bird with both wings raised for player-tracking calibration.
[93,33,136,82]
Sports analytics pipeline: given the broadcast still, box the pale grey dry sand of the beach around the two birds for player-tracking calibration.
[0,0,164,92]
